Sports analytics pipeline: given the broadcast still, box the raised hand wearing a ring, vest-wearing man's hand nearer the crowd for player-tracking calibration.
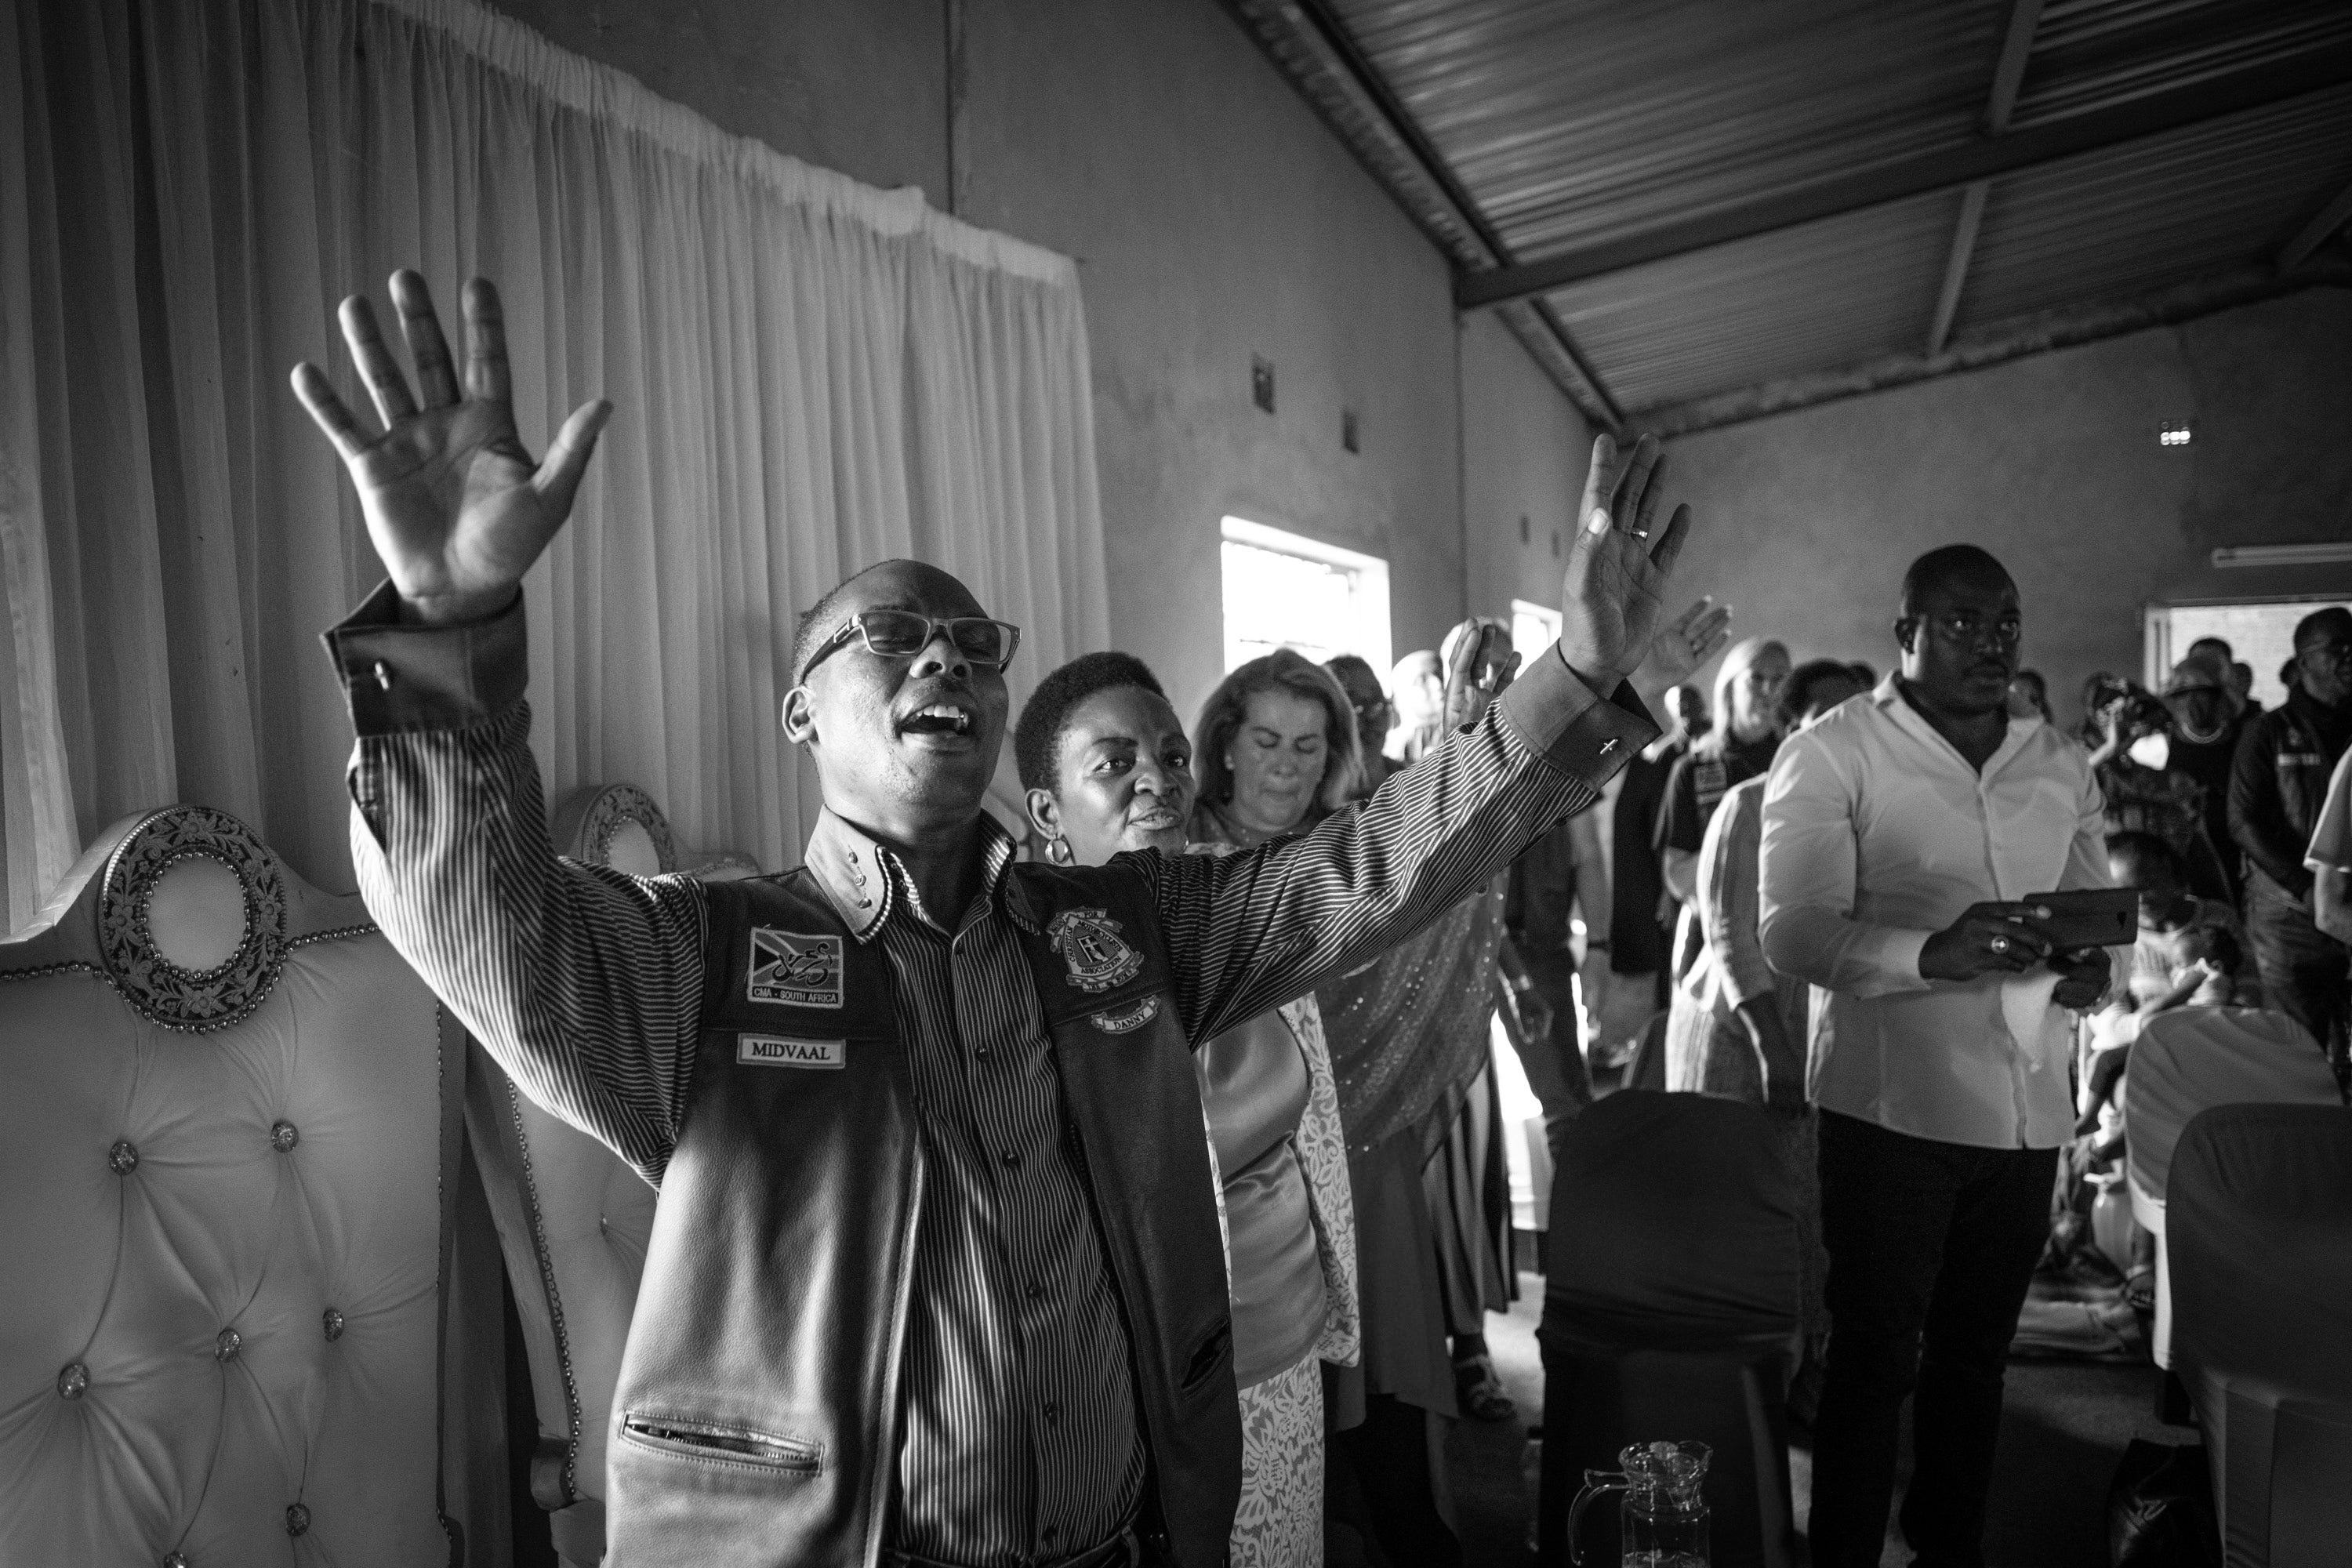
[1559,435,1691,691]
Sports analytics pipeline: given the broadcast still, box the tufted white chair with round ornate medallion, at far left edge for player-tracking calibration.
[0,806,468,1568]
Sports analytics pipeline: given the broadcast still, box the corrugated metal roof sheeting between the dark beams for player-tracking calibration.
[1225,0,2352,423]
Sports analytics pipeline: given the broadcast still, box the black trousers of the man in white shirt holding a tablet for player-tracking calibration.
[1809,1112,2058,1568]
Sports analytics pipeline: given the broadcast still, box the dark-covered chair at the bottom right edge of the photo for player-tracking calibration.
[2164,1105,2352,1568]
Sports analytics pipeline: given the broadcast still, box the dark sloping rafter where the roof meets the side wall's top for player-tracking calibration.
[1225,0,1625,433]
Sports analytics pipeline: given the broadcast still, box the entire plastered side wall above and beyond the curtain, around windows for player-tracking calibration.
[480,0,1583,713]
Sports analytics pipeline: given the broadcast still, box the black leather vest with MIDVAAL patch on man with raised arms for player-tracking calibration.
[607,865,1242,1568]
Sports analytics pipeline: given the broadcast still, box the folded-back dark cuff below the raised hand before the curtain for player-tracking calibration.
[320,581,532,736]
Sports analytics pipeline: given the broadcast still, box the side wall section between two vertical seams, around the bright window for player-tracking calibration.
[960,0,1463,715]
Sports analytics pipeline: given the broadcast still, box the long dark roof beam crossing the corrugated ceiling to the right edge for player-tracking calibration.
[1454,45,2352,310]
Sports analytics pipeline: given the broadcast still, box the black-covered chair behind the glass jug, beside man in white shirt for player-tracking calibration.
[1538,1088,1799,1568]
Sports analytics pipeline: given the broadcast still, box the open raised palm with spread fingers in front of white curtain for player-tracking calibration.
[294,268,612,623]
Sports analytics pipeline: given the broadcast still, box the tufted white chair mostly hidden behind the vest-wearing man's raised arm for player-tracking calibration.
[466,785,757,1568]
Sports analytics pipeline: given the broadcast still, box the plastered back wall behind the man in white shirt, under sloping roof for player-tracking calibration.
[1668,289,2352,720]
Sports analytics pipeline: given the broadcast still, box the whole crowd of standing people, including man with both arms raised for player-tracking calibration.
[296,273,2352,1568]
